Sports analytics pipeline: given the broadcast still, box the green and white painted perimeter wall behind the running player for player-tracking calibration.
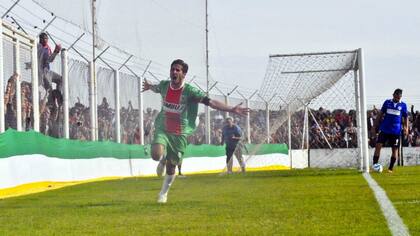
[0,129,290,189]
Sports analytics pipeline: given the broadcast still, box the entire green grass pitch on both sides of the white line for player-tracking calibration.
[0,167,420,235]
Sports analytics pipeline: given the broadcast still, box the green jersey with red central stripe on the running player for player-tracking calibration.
[153,80,206,135]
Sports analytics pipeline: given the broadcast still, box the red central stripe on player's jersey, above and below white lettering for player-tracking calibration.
[165,86,184,134]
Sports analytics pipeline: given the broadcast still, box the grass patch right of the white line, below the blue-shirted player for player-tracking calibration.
[372,166,420,235]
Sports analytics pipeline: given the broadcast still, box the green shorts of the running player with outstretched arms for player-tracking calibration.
[152,130,188,165]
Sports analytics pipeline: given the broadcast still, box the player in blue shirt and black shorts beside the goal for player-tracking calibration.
[373,89,408,173]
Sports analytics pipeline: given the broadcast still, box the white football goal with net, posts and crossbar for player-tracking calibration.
[260,49,369,172]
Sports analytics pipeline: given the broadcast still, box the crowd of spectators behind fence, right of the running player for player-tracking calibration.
[189,106,420,149]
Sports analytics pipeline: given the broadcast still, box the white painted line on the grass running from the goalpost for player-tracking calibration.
[363,173,410,236]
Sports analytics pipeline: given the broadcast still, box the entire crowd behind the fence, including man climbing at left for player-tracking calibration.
[4,33,420,149]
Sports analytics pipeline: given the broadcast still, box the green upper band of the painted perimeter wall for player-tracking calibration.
[0,129,288,159]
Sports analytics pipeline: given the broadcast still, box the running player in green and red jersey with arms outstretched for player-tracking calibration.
[143,59,249,203]
